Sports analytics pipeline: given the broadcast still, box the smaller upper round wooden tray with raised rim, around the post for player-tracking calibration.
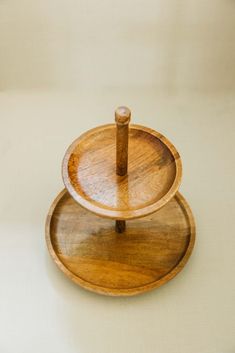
[62,124,182,220]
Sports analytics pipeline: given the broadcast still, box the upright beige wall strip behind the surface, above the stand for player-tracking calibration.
[0,0,235,94]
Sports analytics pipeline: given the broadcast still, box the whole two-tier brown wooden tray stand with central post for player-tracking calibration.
[46,107,195,296]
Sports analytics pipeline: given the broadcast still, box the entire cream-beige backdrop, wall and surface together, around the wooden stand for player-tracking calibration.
[0,0,235,353]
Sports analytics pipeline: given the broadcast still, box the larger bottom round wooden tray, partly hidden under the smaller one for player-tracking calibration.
[46,190,195,296]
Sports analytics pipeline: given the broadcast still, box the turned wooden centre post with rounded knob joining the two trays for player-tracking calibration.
[115,107,131,233]
